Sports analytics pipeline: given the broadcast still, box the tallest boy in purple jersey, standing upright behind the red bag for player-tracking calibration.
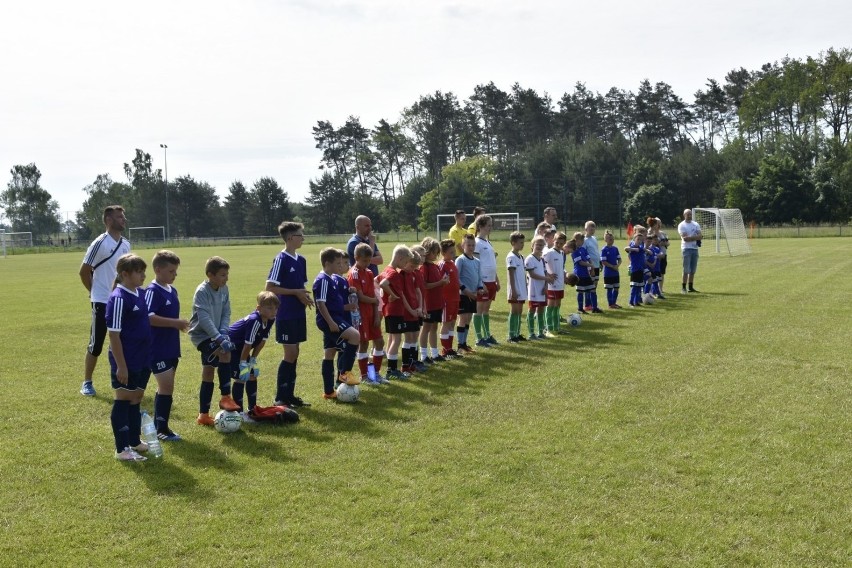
[266,221,314,407]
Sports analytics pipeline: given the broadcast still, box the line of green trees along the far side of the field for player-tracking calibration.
[0,48,852,238]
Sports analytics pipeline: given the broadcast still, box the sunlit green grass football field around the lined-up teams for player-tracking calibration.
[0,238,852,566]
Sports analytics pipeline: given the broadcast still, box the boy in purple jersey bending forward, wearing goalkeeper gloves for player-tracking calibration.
[223,290,281,422]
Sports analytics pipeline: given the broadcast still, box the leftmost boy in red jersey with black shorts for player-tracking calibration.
[376,245,412,379]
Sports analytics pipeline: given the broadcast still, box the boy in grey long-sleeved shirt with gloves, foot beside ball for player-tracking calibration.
[189,256,240,426]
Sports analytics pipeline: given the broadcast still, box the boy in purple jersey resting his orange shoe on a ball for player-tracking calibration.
[313,247,361,399]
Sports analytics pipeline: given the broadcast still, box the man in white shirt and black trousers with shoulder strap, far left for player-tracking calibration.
[80,205,130,396]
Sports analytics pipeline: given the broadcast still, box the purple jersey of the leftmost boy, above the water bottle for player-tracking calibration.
[106,284,151,373]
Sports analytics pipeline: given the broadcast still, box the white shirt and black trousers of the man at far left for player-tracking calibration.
[83,233,130,357]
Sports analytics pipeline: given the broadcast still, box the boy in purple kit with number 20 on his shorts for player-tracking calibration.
[145,250,189,442]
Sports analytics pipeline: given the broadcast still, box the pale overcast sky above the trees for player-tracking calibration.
[0,0,852,220]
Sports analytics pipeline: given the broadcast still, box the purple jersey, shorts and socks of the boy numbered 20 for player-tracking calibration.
[145,280,180,436]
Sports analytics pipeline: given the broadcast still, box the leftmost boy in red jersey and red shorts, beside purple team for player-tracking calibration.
[348,243,388,384]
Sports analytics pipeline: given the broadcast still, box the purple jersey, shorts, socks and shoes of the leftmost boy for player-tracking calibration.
[104,284,151,460]
